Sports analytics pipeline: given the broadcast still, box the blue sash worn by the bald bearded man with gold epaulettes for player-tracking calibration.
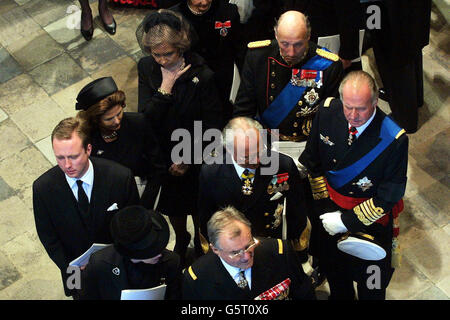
[261,48,333,128]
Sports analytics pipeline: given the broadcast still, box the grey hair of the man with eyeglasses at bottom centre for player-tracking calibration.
[207,206,251,249]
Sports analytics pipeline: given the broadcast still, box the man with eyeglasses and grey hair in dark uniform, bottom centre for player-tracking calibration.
[182,207,315,300]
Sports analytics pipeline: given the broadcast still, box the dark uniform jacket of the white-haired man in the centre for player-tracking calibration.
[198,151,306,249]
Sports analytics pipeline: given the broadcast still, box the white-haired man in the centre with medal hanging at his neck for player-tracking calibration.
[198,117,308,261]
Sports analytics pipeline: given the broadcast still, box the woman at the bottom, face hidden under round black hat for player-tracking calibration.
[81,206,182,300]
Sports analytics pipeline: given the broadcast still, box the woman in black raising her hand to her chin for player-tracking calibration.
[136,9,222,262]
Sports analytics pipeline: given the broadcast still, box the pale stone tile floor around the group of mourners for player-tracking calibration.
[0,0,450,300]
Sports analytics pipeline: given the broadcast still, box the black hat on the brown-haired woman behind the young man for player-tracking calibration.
[75,77,118,110]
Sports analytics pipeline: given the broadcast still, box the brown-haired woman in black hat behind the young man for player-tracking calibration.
[75,77,165,209]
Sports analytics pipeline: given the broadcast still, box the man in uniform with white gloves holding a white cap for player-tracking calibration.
[300,71,408,300]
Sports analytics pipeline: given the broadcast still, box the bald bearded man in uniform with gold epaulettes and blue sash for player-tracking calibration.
[233,11,343,141]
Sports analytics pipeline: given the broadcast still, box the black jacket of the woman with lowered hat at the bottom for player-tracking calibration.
[81,246,182,300]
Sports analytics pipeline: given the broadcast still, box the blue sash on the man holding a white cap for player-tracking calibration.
[325,116,403,188]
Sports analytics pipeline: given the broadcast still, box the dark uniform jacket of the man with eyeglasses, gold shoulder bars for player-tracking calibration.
[183,239,315,300]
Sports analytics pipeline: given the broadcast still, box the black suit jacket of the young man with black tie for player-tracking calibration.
[33,157,139,295]
